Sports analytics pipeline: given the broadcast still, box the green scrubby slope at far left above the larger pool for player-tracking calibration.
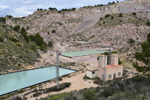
[0,22,49,74]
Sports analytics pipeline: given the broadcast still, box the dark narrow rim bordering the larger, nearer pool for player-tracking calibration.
[0,66,80,97]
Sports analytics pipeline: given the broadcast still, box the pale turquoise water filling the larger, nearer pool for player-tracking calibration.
[0,66,75,95]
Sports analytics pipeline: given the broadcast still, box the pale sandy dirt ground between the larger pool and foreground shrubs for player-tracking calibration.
[29,73,98,100]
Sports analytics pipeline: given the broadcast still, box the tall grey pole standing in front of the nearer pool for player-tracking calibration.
[56,50,61,88]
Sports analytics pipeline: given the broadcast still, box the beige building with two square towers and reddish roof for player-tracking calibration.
[87,54,123,81]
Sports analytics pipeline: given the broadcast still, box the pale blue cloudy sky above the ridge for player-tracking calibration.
[0,0,124,17]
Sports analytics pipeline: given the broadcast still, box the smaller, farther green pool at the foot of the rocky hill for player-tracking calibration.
[61,50,105,58]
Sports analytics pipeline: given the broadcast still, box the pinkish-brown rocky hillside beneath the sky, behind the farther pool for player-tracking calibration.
[4,0,150,50]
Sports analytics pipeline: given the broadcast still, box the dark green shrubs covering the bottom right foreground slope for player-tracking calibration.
[41,75,150,100]
